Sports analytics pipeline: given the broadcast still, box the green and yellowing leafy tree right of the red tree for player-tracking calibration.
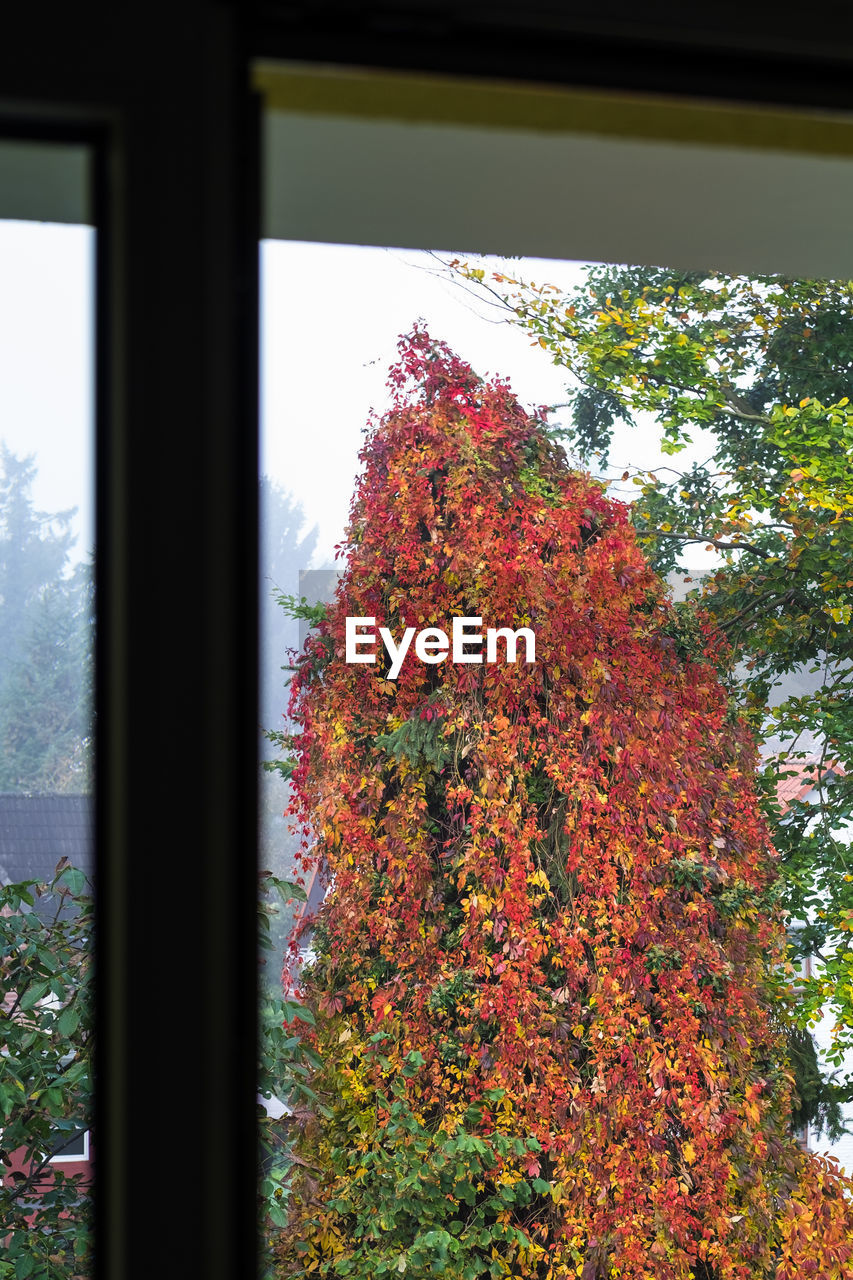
[451,261,853,1119]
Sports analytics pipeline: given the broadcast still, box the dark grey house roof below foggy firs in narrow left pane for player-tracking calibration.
[0,792,95,884]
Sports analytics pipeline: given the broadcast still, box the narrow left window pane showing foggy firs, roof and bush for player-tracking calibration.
[0,167,95,1277]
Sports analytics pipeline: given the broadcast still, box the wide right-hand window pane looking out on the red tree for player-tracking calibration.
[260,74,853,1276]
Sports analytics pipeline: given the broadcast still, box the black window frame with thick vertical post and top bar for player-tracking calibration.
[0,0,853,1280]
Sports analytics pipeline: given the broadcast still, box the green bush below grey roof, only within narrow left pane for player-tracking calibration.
[0,859,92,1280]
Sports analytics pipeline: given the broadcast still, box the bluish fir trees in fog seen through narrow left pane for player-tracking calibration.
[0,444,93,792]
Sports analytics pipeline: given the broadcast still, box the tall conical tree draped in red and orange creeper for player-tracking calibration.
[272,330,853,1280]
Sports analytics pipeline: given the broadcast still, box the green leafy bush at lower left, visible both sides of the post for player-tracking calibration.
[0,859,319,1280]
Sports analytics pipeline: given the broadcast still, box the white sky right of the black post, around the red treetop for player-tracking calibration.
[261,241,716,568]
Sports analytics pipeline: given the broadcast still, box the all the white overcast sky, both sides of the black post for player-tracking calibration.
[0,221,722,568]
